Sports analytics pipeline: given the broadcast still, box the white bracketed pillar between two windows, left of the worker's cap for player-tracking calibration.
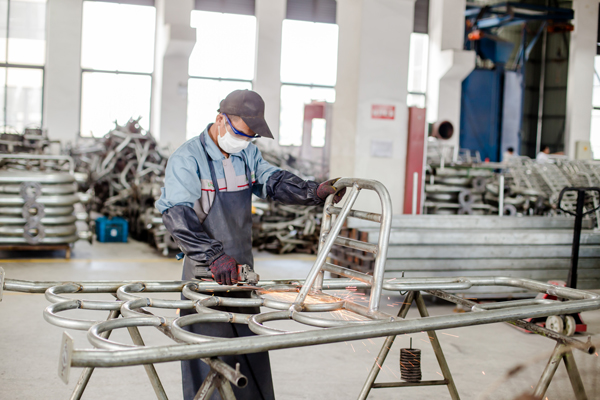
[152,0,196,150]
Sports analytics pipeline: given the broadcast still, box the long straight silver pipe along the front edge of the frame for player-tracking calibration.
[71,299,600,367]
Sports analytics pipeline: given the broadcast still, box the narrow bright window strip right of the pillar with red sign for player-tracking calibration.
[406,33,429,108]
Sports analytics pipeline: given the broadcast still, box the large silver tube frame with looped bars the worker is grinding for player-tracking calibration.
[0,179,600,398]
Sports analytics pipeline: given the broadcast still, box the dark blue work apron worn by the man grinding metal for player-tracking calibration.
[181,135,275,400]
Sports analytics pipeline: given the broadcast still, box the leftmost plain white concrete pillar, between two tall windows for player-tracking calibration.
[44,0,83,145]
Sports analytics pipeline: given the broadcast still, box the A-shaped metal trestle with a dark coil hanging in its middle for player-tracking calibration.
[358,291,460,400]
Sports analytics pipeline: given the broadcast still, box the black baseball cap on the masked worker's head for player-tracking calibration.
[217,89,273,139]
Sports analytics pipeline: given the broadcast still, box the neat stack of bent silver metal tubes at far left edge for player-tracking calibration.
[0,154,92,253]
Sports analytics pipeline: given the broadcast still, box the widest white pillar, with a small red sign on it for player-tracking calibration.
[330,0,414,214]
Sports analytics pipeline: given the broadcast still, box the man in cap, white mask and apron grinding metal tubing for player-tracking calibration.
[156,90,345,400]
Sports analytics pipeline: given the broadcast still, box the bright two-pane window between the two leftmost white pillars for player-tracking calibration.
[81,1,156,137]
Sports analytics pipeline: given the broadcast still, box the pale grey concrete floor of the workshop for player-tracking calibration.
[0,242,600,400]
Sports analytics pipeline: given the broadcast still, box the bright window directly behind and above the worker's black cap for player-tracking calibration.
[187,10,256,138]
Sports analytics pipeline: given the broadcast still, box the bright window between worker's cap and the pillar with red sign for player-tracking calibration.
[279,19,338,146]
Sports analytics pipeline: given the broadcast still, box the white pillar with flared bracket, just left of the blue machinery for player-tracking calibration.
[427,0,475,145]
